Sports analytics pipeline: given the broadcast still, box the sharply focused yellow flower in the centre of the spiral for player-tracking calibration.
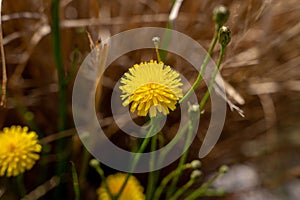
[120,60,182,117]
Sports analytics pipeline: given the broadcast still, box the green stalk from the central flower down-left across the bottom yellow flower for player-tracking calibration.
[116,119,156,199]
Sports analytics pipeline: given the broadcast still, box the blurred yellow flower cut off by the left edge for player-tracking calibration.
[0,126,42,177]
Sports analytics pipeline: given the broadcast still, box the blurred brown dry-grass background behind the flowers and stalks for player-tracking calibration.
[0,0,300,200]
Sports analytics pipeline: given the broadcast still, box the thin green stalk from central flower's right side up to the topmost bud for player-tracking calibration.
[179,24,220,104]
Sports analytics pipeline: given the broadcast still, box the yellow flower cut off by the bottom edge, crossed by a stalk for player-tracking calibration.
[97,173,145,200]
